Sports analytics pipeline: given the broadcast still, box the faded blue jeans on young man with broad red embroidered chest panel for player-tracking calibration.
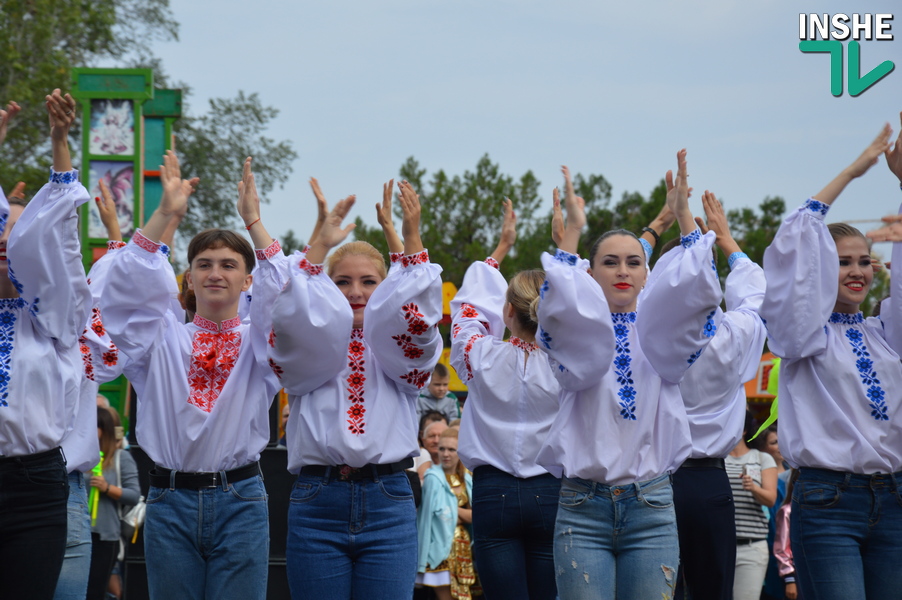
[144,472,269,600]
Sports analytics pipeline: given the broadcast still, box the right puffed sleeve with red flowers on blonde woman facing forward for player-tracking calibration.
[363,250,442,390]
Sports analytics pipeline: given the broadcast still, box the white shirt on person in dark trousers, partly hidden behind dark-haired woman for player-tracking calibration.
[680,253,767,458]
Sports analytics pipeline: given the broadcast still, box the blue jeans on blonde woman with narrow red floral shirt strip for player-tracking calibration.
[286,469,417,600]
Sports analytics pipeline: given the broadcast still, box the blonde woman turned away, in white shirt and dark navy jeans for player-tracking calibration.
[451,200,561,600]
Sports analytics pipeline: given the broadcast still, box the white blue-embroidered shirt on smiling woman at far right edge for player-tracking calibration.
[761,199,902,474]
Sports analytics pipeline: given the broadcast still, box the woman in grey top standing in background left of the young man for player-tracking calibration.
[85,407,141,600]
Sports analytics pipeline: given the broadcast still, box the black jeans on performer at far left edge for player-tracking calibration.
[0,448,69,600]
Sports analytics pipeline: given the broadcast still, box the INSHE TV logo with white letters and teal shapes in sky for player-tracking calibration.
[799,13,896,96]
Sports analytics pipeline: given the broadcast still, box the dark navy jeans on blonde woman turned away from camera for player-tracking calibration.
[473,465,561,600]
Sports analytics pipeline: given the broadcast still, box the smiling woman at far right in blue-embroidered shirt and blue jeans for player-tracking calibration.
[760,118,902,600]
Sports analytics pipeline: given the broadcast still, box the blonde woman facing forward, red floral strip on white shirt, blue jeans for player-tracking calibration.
[270,181,442,600]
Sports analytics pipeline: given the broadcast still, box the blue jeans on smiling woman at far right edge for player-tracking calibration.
[789,467,902,600]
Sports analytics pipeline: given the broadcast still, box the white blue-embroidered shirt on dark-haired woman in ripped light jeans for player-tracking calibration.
[537,230,722,485]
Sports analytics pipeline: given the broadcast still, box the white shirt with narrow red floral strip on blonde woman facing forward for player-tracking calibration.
[268,250,442,473]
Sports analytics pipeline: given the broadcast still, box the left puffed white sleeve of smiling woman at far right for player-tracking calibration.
[761,199,839,358]
